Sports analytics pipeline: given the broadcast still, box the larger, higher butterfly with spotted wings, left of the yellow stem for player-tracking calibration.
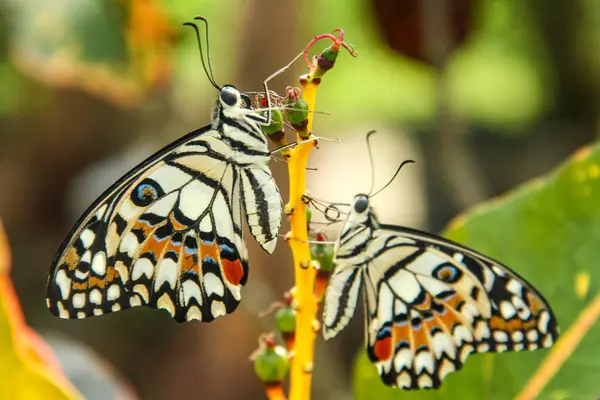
[47,17,282,322]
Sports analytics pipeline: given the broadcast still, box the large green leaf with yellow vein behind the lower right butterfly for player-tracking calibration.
[355,145,600,400]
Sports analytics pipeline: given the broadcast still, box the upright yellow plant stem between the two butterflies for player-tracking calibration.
[285,76,318,400]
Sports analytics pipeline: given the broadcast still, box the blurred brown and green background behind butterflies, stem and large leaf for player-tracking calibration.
[0,0,600,399]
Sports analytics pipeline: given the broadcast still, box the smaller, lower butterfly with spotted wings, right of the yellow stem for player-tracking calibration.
[323,162,559,389]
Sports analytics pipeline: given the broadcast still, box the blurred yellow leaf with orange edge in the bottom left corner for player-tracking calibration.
[0,222,80,400]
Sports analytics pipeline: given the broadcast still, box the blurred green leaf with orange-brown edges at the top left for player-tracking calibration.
[10,0,175,105]
